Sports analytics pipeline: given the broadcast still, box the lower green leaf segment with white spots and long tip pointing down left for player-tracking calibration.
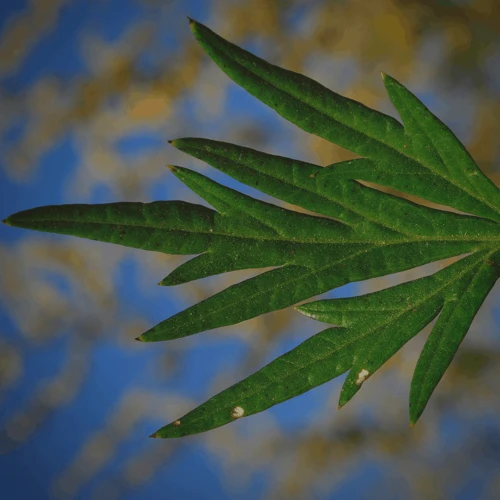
[153,253,498,438]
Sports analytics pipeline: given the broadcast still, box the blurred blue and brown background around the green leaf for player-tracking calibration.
[0,0,500,500]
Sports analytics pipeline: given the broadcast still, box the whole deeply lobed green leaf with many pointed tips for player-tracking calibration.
[4,17,500,437]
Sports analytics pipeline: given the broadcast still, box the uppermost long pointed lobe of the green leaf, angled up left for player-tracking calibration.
[190,21,406,160]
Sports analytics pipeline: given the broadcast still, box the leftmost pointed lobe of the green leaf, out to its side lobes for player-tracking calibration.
[4,201,217,254]
